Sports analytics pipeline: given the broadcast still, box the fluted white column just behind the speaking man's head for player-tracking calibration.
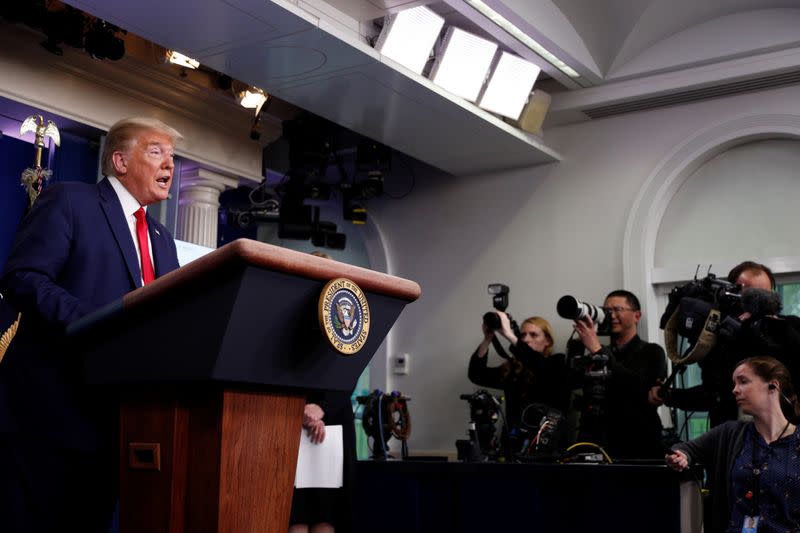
[176,168,239,248]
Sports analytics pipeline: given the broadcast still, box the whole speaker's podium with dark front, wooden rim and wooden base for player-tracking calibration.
[73,239,420,533]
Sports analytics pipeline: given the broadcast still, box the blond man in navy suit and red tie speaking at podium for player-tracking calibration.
[0,118,182,533]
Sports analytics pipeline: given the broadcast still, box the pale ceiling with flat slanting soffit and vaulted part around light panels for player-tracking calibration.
[61,0,800,175]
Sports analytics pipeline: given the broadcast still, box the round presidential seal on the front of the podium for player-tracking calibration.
[318,278,370,355]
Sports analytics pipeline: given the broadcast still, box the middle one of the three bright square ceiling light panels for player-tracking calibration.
[431,26,497,102]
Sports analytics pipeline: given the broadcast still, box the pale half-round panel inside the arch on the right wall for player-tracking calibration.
[655,139,800,266]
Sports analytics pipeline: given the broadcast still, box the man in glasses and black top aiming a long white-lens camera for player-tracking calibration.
[574,290,667,459]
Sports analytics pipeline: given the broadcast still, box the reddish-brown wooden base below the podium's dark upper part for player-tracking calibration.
[120,389,305,533]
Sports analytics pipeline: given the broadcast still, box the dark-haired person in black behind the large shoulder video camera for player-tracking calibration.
[651,261,800,427]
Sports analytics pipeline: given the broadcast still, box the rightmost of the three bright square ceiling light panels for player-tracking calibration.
[478,52,541,120]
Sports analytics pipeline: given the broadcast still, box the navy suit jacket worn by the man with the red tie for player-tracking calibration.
[0,179,179,451]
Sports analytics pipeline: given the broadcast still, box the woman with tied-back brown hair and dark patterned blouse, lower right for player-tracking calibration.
[666,357,800,533]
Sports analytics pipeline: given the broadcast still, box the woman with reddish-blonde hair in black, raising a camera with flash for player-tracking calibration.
[467,311,569,428]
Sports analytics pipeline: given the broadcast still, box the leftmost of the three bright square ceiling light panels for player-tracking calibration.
[375,6,444,74]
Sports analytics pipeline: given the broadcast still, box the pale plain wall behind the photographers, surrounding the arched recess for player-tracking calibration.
[372,87,800,453]
